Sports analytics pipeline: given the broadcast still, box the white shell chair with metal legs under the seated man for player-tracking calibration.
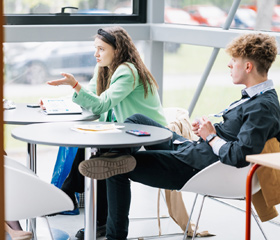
[180,161,267,240]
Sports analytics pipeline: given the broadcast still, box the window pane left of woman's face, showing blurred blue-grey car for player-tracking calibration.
[4,41,96,84]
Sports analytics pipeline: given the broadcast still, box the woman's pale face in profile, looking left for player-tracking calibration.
[94,38,115,67]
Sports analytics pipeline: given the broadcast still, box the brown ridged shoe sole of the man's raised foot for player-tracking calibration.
[79,153,136,180]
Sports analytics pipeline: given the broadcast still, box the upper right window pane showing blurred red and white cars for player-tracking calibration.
[165,0,280,32]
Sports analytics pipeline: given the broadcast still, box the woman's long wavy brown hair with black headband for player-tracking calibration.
[95,26,158,97]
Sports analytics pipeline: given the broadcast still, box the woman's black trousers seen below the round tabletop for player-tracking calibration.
[61,148,108,226]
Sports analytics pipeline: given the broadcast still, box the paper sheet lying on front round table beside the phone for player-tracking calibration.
[71,124,124,133]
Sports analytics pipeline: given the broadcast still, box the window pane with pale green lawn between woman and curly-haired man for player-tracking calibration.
[163,44,280,121]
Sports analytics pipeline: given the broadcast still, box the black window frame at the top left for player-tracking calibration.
[4,0,147,25]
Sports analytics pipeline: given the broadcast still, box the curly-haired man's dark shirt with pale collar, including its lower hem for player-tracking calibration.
[172,80,280,169]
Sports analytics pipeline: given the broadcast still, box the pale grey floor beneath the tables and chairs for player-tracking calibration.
[6,147,280,240]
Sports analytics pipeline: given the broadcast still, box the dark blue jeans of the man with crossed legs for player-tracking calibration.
[106,114,198,240]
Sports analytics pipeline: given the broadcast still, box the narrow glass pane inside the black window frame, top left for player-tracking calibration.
[4,0,132,14]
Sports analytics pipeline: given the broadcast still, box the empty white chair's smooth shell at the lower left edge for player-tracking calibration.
[4,156,74,221]
